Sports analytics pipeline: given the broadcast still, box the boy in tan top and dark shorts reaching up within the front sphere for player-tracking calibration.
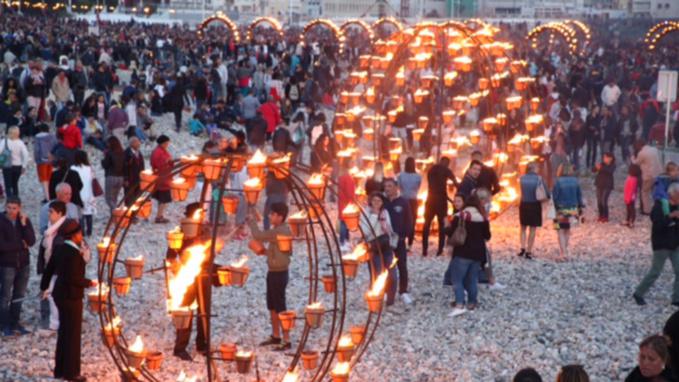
[248,202,292,351]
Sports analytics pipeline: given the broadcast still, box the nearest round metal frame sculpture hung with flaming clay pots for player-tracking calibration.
[95,151,395,381]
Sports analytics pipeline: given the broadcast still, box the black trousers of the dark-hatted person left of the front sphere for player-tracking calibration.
[54,299,83,379]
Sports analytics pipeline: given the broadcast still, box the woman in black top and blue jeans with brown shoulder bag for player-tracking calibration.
[448,195,490,317]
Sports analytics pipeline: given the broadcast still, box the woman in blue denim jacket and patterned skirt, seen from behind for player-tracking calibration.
[552,163,584,258]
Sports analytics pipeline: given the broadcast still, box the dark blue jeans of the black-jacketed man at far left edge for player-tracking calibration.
[0,265,30,328]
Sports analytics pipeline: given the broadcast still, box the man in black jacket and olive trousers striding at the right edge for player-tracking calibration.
[632,183,679,306]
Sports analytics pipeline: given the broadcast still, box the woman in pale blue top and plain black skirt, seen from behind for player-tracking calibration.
[517,162,549,260]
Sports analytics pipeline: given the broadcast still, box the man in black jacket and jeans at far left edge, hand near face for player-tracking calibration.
[0,198,35,336]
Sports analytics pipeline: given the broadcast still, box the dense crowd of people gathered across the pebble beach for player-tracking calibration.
[0,8,679,382]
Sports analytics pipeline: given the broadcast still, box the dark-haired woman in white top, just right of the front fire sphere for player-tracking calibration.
[360,192,398,306]
